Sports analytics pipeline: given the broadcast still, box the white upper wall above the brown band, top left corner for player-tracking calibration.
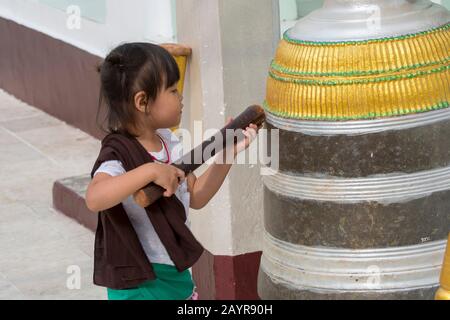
[0,0,176,57]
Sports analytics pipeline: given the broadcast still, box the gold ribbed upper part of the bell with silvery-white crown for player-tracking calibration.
[265,0,450,121]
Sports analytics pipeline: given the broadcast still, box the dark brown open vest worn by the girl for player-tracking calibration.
[91,133,204,289]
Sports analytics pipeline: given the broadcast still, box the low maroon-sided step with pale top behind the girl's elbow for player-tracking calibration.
[53,174,98,232]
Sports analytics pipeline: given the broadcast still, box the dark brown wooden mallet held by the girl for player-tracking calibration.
[134,105,266,208]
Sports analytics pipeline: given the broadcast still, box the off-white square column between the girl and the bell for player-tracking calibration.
[177,0,279,256]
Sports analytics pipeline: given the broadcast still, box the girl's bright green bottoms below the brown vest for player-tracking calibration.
[108,263,195,300]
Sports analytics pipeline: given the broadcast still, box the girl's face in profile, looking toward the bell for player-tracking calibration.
[138,83,183,129]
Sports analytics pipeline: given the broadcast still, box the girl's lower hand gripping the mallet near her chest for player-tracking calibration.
[150,162,185,198]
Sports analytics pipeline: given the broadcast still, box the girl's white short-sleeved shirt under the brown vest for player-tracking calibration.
[94,129,190,266]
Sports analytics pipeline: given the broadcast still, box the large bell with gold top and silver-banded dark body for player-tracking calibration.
[258,0,450,299]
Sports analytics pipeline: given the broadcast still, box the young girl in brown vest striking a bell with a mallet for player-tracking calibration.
[86,43,258,300]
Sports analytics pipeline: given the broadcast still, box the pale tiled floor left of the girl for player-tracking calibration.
[0,90,106,300]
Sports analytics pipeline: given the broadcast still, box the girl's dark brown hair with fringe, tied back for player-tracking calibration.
[96,43,180,136]
